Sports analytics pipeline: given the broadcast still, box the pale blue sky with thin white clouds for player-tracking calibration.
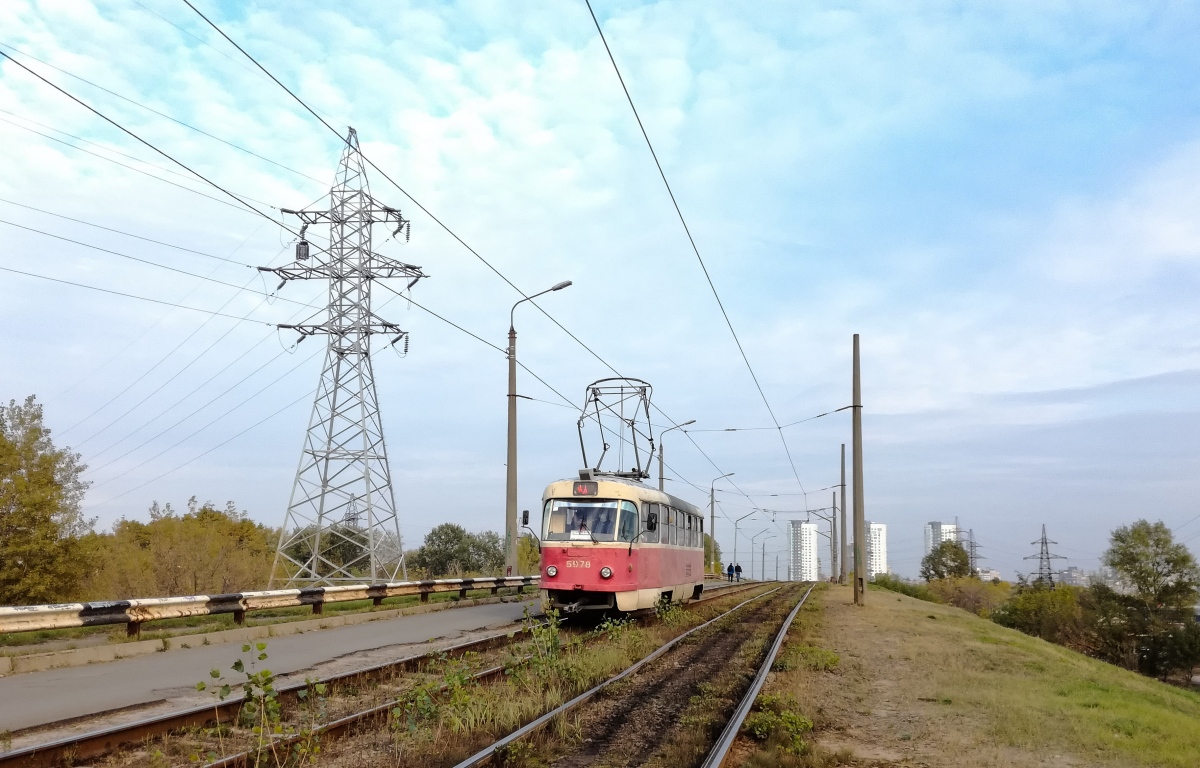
[0,0,1200,578]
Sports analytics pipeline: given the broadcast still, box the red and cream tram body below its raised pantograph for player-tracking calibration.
[541,470,704,613]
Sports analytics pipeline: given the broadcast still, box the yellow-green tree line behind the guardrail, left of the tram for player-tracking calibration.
[0,397,523,605]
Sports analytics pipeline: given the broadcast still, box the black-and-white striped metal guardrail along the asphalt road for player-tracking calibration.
[0,576,541,636]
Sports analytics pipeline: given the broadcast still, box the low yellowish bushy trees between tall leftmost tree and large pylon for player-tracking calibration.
[86,497,278,600]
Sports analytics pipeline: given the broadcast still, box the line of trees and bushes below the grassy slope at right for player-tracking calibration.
[876,520,1200,684]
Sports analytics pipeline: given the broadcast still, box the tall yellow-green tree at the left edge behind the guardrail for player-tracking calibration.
[0,395,91,605]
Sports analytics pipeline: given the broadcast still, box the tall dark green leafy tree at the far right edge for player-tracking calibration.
[1098,520,1200,679]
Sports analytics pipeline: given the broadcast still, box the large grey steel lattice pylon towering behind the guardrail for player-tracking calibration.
[259,128,425,586]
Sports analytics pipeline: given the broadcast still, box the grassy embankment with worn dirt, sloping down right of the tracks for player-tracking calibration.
[736,587,1200,768]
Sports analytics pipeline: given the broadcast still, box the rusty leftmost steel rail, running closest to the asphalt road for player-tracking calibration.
[0,628,527,768]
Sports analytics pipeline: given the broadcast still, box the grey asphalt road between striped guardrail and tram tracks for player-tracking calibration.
[0,602,533,732]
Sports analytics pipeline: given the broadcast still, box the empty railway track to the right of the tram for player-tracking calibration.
[455,586,812,768]
